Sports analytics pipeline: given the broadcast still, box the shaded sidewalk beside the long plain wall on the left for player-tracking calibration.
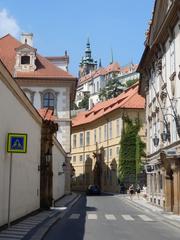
[0,193,80,240]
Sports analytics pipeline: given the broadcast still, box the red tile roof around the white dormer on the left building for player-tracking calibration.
[0,34,76,80]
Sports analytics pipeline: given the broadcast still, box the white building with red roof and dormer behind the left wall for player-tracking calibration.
[0,34,77,195]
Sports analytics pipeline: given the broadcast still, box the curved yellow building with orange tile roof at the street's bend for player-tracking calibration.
[71,84,145,192]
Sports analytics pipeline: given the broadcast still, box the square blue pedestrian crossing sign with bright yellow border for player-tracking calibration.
[7,133,27,153]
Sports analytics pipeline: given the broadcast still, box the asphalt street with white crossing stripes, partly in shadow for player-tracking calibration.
[44,195,180,240]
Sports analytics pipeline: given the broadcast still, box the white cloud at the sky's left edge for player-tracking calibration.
[0,9,21,37]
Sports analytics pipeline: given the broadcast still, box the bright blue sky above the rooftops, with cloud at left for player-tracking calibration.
[0,0,154,76]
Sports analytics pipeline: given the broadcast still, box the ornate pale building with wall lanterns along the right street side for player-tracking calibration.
[138,0,180,214]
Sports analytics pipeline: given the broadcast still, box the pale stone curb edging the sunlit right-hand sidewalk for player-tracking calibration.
[123,198,180,229]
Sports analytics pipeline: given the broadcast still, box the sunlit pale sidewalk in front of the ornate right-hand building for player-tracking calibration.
[118,195,180,228]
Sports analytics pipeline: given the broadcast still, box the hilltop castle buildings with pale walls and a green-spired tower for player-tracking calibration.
[75,40,139,109]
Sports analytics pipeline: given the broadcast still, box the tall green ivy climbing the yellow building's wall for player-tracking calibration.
[118,118,145,184]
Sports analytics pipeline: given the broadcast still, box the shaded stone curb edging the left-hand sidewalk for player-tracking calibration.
[30,195,81,240]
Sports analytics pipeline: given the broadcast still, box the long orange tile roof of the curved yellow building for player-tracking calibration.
[72,83,145,127]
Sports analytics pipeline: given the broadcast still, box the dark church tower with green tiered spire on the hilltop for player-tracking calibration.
[79,39,97,78]
